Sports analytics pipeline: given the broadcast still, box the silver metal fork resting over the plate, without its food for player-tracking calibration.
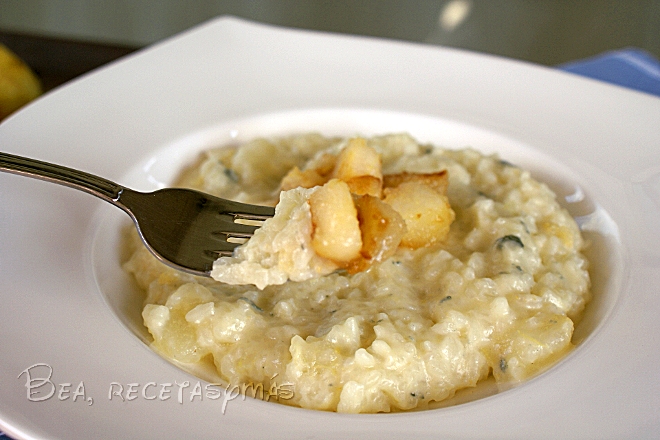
[0,152,275,276]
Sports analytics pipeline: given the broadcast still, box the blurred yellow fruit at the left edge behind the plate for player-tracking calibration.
[0,44,41,120]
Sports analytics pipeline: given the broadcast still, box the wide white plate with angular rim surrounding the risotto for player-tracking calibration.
[0,18,660,438]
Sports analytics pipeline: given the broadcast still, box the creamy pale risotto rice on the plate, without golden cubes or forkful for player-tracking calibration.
[124,134,590,413]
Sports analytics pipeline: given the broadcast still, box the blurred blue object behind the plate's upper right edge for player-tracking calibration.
[557,48,660,96]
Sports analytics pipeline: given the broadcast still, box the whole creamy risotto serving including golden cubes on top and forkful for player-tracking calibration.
[124,134,590,413]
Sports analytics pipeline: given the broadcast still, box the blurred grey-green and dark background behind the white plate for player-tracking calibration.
[0,0,660,89]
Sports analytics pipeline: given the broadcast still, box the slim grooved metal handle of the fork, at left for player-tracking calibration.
[0,152,124,203]
